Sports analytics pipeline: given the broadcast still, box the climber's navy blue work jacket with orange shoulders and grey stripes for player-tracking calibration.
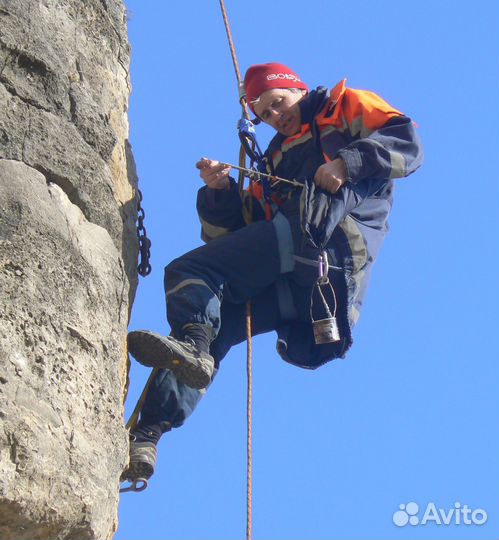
[197,81,423,368]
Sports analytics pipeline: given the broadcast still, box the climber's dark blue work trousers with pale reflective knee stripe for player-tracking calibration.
[141,209,334,427]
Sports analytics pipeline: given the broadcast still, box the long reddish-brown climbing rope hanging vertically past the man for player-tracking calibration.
[220,0,253,540]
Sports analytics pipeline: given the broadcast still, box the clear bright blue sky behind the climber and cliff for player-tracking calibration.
[116,0,499,540]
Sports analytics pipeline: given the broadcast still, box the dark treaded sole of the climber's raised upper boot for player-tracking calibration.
[128,330,211,390]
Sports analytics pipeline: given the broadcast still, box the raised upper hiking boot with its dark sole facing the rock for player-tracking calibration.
[128,330,215,389]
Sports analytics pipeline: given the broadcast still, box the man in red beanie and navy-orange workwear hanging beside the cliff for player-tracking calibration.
[124,63,422,486]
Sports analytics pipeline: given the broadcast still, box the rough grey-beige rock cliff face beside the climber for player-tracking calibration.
[0,0,137,540]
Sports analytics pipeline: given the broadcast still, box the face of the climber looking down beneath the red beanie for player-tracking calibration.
[253,88,305,137]
